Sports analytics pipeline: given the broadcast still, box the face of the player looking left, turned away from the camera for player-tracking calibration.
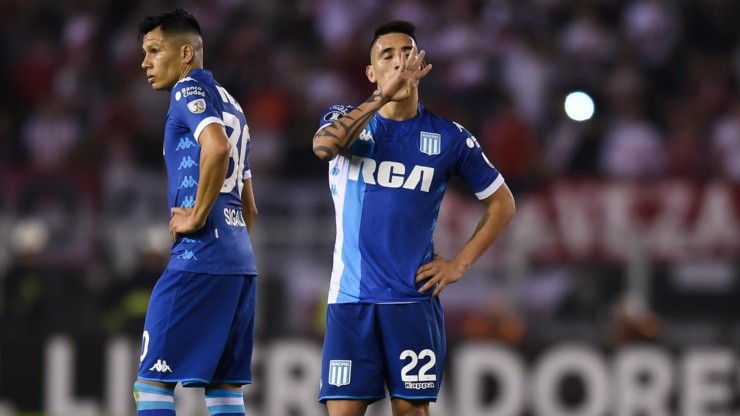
[141,27,183,91]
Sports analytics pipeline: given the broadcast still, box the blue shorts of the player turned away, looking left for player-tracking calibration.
[138,269,256,387]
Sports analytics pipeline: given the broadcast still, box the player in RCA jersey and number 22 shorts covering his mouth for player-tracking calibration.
[313,21,514,416]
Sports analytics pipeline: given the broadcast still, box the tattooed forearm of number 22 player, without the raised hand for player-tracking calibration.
[313,90,390,162]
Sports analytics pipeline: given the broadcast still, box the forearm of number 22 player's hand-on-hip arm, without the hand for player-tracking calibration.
[453,184,516,271]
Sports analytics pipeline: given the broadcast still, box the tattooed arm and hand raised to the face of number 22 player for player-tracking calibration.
[313,48,432,162]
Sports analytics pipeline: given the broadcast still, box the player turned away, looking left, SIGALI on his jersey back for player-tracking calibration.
[134,9,257,416]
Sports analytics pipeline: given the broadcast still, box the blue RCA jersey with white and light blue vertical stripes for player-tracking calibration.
[319,104,504,303]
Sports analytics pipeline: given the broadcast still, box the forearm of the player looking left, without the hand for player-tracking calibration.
[193,145,229,227]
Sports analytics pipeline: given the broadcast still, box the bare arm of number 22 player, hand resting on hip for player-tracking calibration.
[416,183,516,296]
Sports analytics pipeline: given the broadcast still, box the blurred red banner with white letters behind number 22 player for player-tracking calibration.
[438,180,740,262]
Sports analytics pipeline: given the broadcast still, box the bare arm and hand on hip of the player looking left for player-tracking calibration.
[169,123,231,239]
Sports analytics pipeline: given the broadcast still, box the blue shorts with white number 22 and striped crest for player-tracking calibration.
[319,298,446,403]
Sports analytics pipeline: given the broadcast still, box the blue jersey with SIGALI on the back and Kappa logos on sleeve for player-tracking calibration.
[164,69,257,274]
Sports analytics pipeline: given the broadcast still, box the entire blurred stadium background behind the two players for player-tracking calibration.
[0,0,740,416]
